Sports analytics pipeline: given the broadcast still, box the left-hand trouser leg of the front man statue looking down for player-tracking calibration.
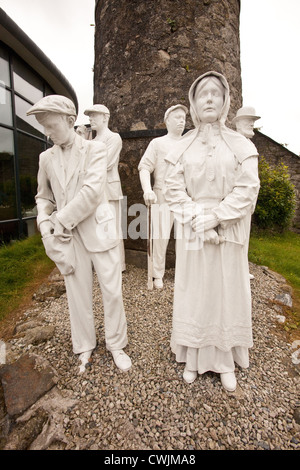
[65,235,96,354]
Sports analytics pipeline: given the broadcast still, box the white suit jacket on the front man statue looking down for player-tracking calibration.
[36,134,119,252]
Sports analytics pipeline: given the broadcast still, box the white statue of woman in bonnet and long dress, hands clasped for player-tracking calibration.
[165,72,259,391]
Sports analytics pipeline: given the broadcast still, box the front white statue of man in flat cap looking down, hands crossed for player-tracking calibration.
[27,95,131,372]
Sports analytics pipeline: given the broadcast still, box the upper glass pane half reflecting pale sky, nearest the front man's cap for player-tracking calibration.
[13,57,43,103]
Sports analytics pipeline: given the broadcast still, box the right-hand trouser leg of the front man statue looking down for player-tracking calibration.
[92,246,127,351]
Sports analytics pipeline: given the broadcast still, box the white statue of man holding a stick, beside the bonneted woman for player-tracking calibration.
[138,104,188,289]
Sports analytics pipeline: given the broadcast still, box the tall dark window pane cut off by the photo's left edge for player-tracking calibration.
[0,127,17,220]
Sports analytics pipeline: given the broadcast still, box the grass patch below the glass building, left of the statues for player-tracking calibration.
[0,234,54,321]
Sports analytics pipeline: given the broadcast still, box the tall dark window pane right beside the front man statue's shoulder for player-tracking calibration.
[18,132,45,217]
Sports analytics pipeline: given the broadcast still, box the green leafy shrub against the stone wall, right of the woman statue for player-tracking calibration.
[253,157,296,231]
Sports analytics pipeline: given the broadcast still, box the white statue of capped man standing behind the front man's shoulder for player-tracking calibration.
[84,104,126,271]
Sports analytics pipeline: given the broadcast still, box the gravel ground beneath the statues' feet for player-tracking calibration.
[5,265,300,451]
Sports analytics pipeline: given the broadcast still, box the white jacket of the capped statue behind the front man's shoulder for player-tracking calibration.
[95,129,123,201]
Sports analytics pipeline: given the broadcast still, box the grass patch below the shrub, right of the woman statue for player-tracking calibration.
[249,230,300,340]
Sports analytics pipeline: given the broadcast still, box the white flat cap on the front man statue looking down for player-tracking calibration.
[26,95,77,116]
